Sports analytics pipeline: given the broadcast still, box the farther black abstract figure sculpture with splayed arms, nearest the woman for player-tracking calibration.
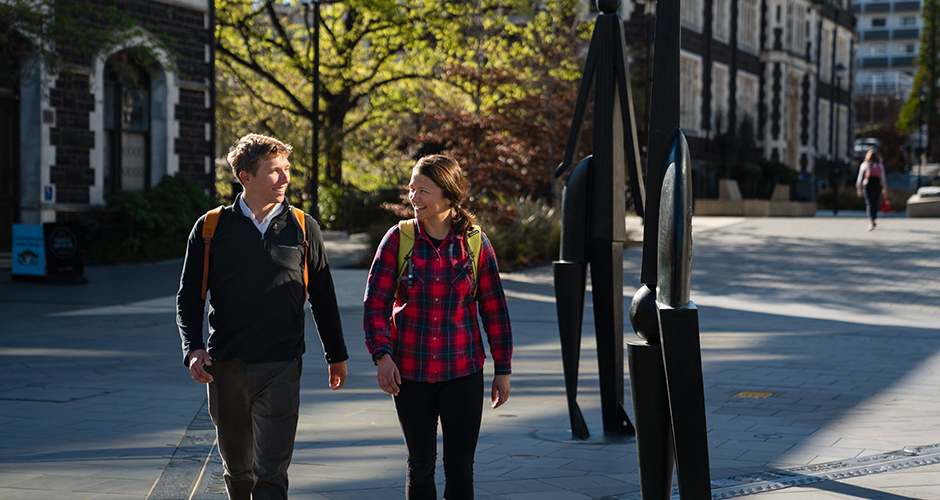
[552,0,643,439]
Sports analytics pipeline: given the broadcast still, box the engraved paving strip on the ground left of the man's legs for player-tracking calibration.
[146,399,215,500]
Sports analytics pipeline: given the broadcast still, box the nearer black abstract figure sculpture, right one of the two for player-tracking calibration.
[627,0,711,500]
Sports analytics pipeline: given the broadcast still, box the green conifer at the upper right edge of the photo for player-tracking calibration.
[897,0,940,159]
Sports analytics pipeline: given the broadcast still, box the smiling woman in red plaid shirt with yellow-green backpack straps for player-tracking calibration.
[364,155,512,500]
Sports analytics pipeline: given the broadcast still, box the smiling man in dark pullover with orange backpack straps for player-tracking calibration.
[176,134,349,500]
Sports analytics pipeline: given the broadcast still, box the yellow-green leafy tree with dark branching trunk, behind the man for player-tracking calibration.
[216,0,439,214]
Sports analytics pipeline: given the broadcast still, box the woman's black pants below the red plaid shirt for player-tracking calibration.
[395,370,483,500]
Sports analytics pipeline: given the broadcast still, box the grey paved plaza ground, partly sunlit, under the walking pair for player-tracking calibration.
[0,212,940,500]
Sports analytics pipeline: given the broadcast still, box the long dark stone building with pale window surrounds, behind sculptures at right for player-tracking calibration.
[622,0,856,200]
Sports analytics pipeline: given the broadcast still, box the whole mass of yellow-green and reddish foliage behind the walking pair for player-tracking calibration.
[216,0,590,227]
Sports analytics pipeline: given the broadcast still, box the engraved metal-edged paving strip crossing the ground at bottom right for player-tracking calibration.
[602,444,940,500]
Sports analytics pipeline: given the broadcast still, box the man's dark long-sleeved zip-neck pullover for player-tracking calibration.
[176,196,349,364]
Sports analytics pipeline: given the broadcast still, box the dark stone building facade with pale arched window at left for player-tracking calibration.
[0,0,215,251]
